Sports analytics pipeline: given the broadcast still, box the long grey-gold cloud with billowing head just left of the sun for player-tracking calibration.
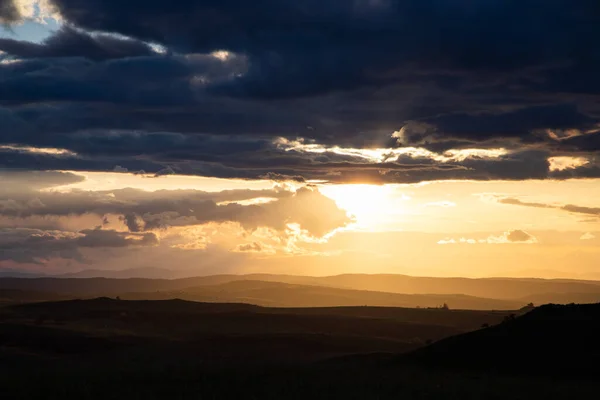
[0,180,351,237]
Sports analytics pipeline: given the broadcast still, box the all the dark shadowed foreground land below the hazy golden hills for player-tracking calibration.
[0,298,600,399]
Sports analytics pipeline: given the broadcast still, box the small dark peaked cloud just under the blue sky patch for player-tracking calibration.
[0,26,155,61]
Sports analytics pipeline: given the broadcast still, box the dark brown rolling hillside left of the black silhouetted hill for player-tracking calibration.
[0,298,508,363]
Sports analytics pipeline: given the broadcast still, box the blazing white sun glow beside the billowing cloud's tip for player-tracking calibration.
[319,185,407,229]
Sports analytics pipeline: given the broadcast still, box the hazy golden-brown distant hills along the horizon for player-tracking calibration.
[0,270,600,309]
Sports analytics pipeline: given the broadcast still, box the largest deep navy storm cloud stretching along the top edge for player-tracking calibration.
[39,0,600,97]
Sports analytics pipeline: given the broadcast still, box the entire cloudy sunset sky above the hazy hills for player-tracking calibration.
[0,0,600,279]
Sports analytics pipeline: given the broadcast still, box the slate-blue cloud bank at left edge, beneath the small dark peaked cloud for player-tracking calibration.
[0,54,242,107]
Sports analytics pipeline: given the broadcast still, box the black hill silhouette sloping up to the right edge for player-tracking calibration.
[403,304,600,377]
